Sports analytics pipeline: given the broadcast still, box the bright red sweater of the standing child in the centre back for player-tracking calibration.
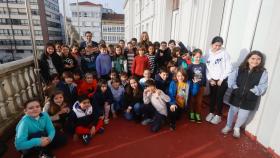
[131,55,150,76]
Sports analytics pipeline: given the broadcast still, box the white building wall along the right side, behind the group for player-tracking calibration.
[124,0,280,155]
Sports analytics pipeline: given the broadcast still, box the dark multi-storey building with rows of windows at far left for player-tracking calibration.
[0,0,62,62]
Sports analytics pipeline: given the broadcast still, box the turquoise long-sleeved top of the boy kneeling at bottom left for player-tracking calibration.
[15,112,55,150]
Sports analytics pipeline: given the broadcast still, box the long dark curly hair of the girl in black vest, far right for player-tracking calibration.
[239,50,265,71]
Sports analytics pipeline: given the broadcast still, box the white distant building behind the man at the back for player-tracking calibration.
[70,2,102,42]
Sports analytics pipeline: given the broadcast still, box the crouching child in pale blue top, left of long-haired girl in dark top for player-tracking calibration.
[110,78,124,118]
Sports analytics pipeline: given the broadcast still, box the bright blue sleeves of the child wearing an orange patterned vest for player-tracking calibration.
[168,80,199,105]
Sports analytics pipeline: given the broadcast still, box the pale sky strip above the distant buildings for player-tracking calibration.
[59,0,125,16]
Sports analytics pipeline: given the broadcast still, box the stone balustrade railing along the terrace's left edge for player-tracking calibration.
[0,57,38,135]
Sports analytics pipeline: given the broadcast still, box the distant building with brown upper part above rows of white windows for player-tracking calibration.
[102,13,124,44]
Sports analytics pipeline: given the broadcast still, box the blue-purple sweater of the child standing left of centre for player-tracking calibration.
[96,53,112,77]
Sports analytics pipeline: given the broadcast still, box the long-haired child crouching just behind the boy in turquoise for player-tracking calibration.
[43,90,70,130]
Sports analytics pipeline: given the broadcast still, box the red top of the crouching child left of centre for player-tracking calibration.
[78,79,97,98]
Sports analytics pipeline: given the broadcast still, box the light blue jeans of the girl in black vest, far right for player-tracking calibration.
[227,105,250,128]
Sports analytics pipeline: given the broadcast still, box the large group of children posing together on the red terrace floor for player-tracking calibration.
[15,32,267,157]
